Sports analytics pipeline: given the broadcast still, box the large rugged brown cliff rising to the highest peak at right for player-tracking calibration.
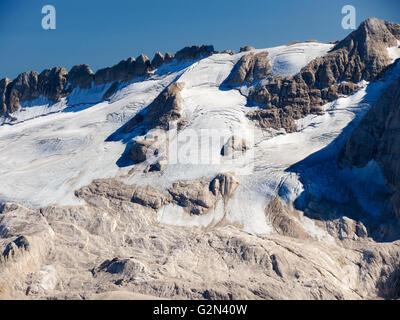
[242,18,400,130]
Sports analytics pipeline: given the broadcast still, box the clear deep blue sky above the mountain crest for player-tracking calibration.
[0,0,400,78]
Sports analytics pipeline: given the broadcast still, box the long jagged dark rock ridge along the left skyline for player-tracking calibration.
[0,45,214,116]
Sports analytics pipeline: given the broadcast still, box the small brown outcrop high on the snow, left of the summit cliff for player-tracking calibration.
[225,51,271,86]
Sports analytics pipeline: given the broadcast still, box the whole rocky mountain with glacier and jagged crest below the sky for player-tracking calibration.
[0,18,400,299]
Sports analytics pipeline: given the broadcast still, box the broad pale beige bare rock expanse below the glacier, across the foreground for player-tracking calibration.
[0,182,400,300]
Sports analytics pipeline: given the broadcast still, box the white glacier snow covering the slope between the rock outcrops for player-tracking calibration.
[0,43,396,240]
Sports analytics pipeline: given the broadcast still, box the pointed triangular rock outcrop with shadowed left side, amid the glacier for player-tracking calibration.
[124,82,185,132]
